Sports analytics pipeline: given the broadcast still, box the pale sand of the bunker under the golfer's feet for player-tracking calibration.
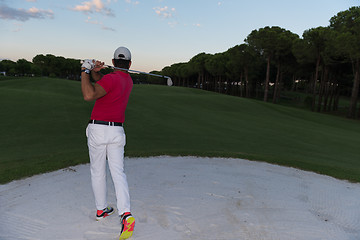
[0,156,360,240]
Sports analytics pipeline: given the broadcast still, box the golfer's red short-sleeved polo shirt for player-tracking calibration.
[91,71,133,123]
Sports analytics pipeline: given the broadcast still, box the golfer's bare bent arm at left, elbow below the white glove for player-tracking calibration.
[81,69,106,101]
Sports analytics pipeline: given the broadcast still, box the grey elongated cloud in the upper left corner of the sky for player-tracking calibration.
[0,4,54,22]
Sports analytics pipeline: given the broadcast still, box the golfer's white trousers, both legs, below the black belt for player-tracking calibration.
[86,124,130,215]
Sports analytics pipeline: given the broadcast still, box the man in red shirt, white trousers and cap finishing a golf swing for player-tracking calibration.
[81,47,135,239]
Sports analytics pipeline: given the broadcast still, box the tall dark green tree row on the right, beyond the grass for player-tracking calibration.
[162,7,360,118]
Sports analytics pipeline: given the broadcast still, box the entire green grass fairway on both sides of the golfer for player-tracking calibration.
[0,78,360,183]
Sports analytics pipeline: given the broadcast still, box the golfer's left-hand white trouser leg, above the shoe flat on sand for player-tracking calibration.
[88,125,107,210]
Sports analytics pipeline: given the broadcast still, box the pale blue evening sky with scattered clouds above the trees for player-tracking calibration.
[0,0,360,72]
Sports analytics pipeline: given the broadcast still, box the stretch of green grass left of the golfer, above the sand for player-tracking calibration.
[0,78,91,183]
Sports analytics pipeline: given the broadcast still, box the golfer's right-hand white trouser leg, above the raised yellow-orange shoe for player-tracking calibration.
[107,127,130,215]
